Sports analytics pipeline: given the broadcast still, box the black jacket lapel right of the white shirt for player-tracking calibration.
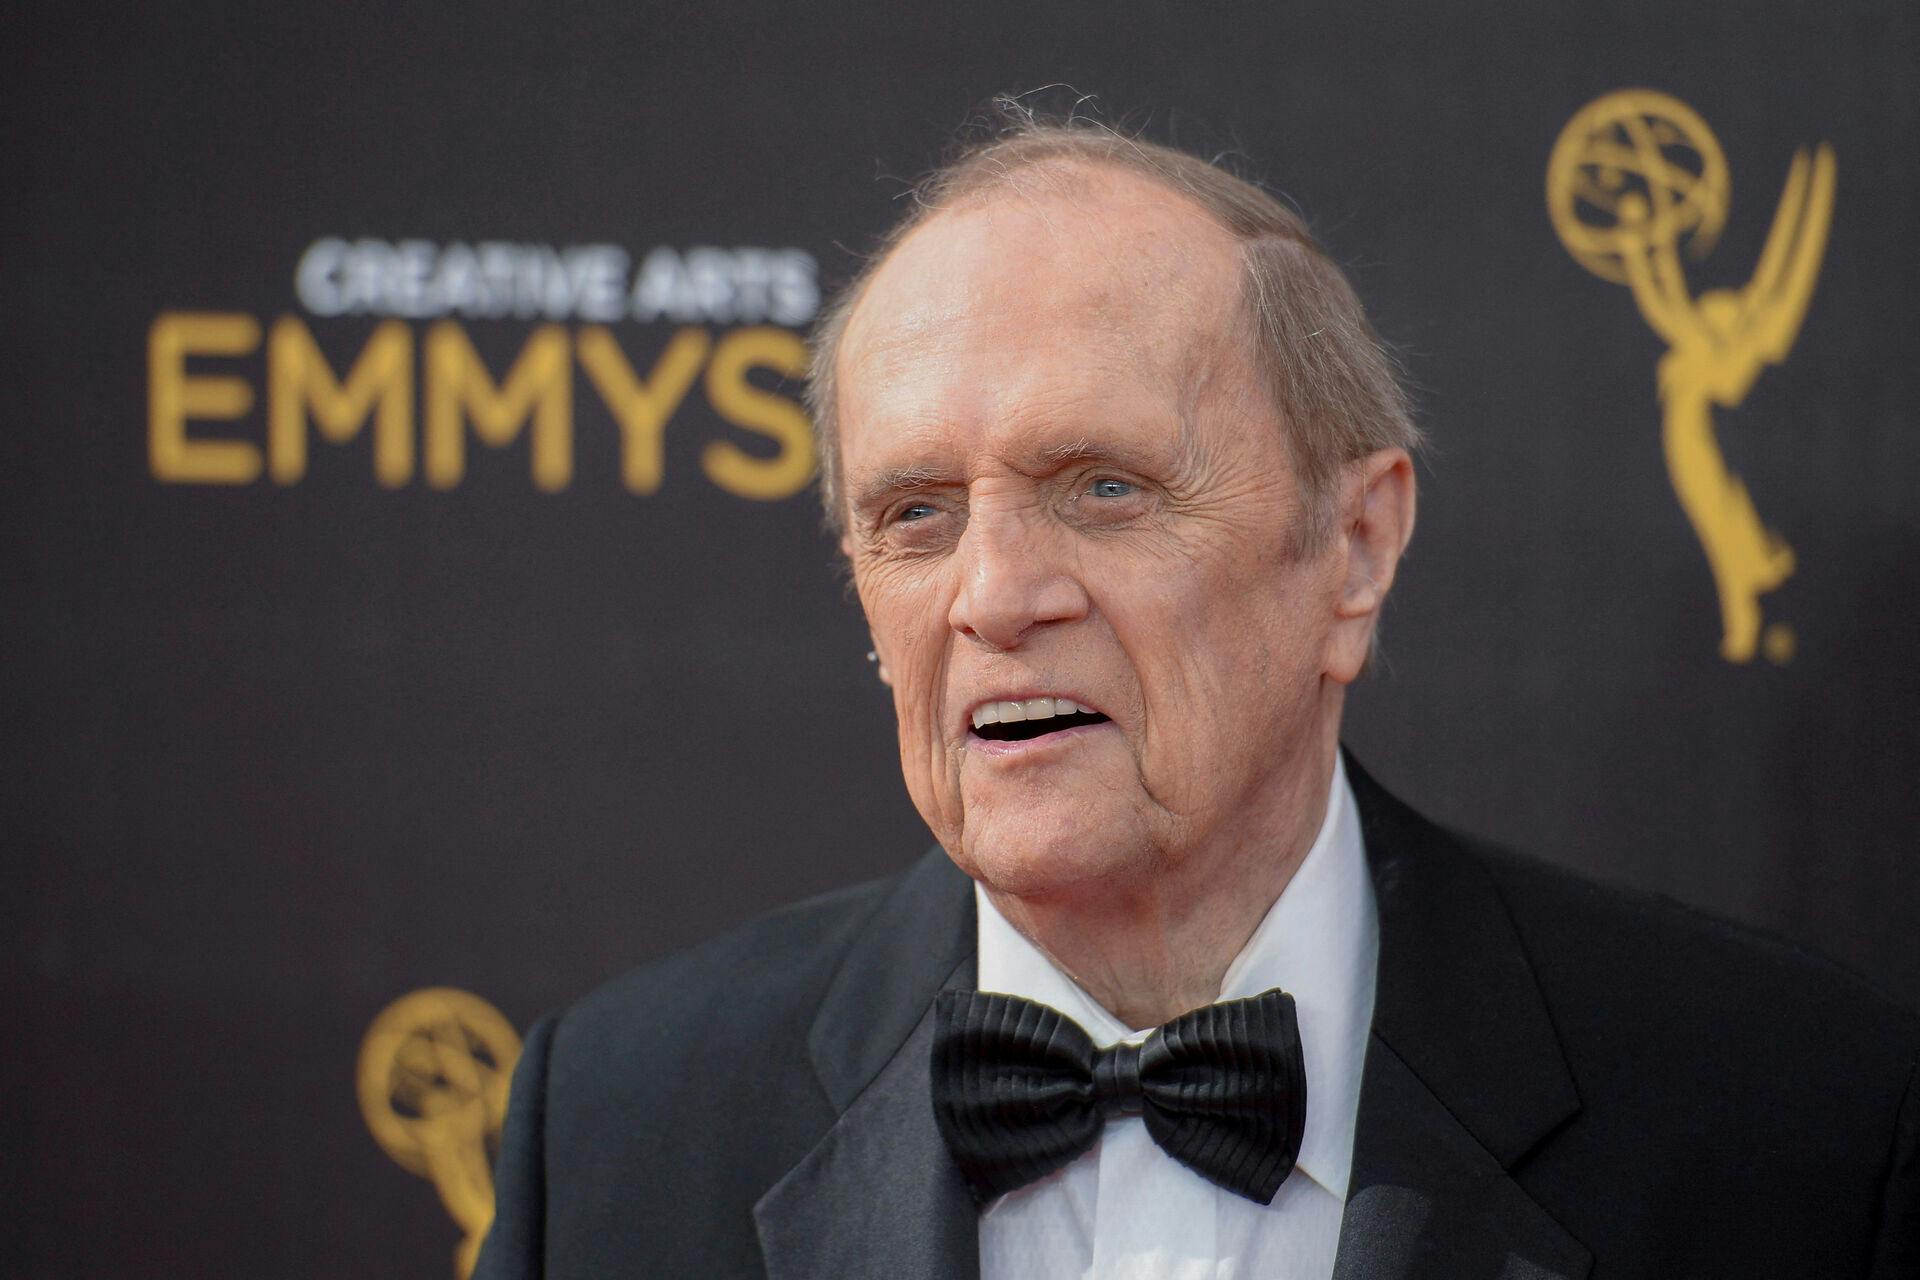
[1334,756,1592,1280]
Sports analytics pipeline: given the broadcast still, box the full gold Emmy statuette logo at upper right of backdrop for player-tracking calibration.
[1548,88,1834,662]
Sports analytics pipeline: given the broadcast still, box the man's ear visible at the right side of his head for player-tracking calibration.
[1327,449,1415,685]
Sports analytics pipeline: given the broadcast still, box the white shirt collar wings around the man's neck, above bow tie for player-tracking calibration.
[973,754,1380,1199]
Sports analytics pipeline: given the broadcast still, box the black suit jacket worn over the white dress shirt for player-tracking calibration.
[478,762,1920,1280]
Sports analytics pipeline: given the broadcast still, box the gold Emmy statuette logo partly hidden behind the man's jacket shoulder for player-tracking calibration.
[359,986,520,1280]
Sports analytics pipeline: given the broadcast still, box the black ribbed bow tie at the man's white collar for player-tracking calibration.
[933,988,1308,1205]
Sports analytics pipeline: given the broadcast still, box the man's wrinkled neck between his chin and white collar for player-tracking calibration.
[987,745,1332,1029]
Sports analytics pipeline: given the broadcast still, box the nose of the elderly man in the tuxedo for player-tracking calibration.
[947,510,1089,649]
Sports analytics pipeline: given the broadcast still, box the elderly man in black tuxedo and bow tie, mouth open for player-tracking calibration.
[480,123,1920,1280]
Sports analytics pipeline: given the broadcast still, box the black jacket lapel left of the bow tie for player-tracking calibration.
[753,850,979,1280]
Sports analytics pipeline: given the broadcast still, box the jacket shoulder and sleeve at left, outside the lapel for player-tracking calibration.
[490,867,906,1276]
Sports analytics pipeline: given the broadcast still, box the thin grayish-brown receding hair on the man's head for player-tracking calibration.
[806,98,1421,549]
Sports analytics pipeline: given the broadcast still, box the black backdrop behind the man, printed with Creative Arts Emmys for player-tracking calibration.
[0,2,1920,1276]
